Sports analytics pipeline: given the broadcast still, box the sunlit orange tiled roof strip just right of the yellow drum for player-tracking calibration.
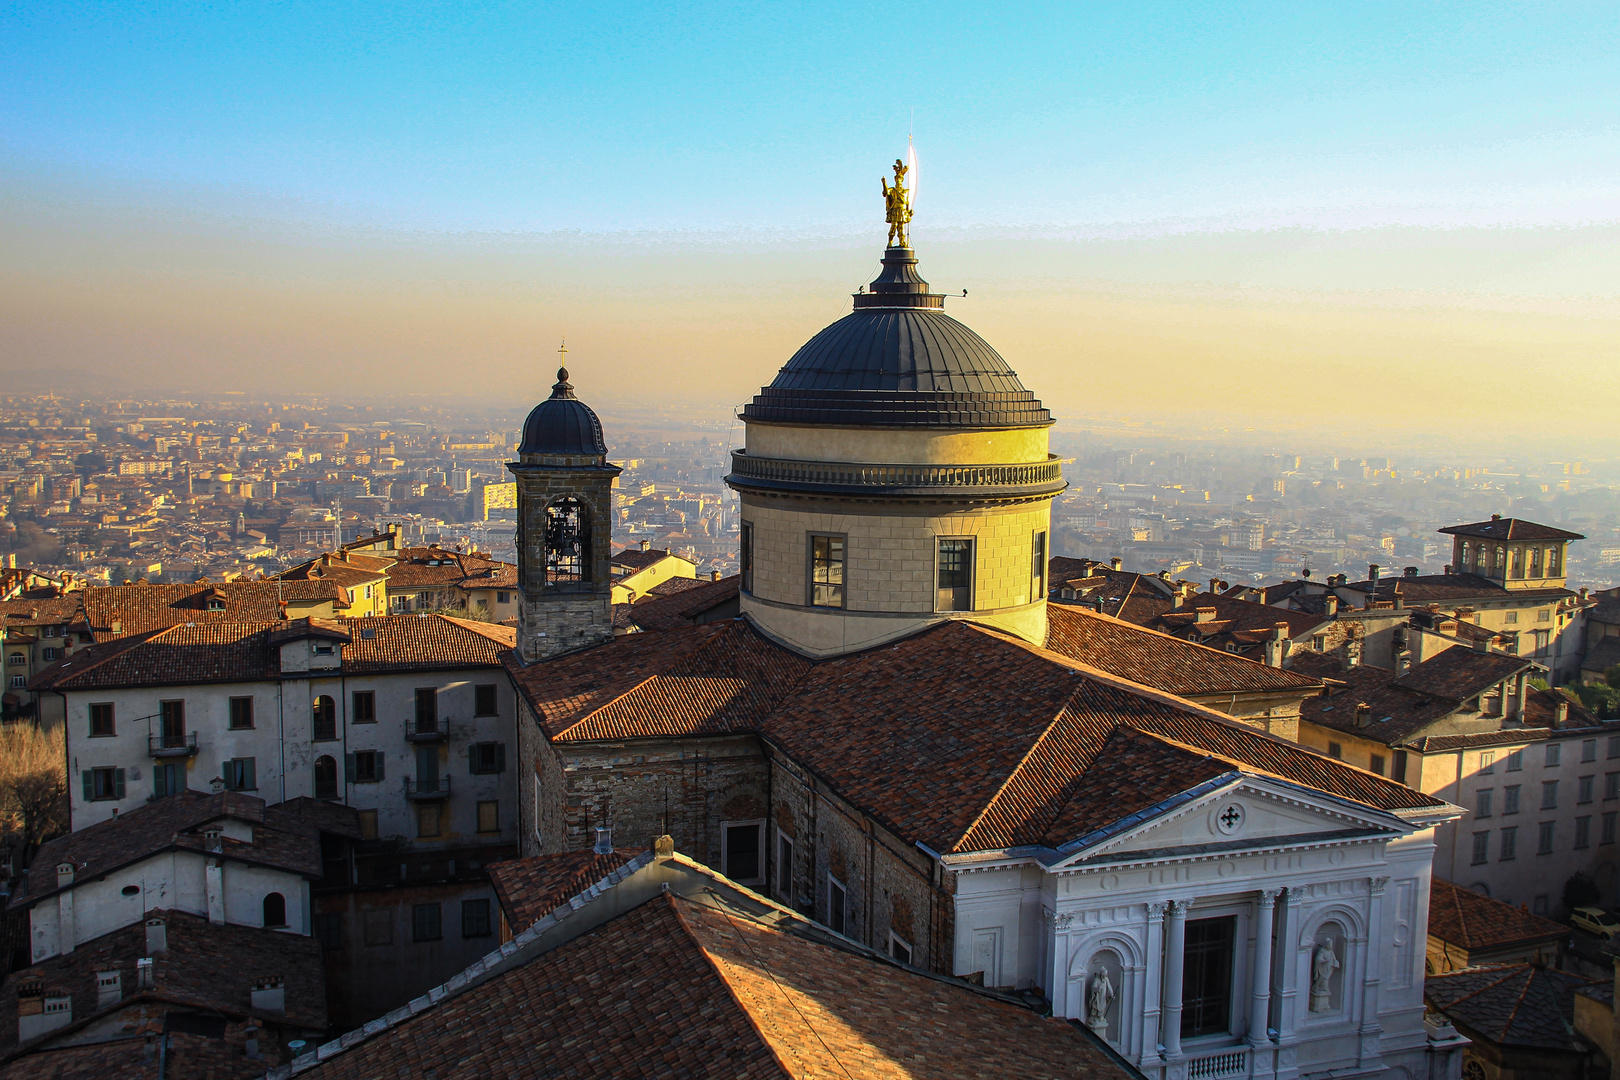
[1047,606,1320,698]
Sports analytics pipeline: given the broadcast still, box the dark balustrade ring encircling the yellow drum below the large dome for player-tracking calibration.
[727,450,1063,494]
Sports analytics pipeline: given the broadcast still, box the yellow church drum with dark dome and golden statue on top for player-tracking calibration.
[726,162,1066,657]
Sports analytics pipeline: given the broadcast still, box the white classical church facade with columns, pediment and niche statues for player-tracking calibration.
[946,774,1458,1080]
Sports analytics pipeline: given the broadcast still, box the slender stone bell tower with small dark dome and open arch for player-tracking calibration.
[507,348,620,664]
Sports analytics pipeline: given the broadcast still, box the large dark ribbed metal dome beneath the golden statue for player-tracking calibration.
[742,248,1053,427]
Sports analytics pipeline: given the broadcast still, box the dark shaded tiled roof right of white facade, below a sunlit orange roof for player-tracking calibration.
[1422,963,1612,1052]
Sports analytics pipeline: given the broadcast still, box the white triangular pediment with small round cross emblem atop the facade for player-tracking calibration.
[1058,774,1411,865]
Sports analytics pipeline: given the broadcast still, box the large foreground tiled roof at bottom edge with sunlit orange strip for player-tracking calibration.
[272,894,1131,1080]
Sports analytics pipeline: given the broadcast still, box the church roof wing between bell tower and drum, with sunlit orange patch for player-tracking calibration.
[505,620,810,742]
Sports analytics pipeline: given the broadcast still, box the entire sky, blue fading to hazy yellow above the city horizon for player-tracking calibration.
[0,2,1620,437]
